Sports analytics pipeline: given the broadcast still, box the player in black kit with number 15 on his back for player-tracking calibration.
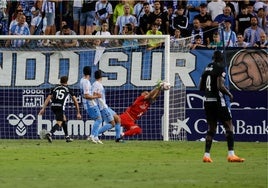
[39,76,81,143]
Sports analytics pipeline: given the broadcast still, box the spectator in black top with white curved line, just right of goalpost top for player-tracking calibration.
[172,6,189,37]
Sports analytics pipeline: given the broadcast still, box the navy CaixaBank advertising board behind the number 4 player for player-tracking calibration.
[183,91,268,141]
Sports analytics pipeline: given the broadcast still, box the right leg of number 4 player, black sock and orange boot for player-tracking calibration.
[220,107,245,162]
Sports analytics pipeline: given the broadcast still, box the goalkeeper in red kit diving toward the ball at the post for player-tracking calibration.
[117,81,169,141]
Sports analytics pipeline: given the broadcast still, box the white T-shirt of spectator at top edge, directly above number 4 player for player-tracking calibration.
[207,0,226,20]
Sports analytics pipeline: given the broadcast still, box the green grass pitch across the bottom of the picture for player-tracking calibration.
[0,140,268,188]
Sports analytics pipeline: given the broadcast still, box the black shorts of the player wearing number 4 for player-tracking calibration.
[204,102,232,122]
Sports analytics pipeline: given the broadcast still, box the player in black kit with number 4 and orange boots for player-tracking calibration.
[200,51,245,163]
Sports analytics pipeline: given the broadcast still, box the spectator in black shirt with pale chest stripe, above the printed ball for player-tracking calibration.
[235,4,252,33]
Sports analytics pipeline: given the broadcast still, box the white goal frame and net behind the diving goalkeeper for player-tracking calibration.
[0,35,186,141]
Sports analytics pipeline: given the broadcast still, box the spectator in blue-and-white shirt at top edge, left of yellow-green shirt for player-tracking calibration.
[95,0,113,26]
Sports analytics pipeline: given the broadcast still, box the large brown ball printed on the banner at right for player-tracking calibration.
[229,49,268,91]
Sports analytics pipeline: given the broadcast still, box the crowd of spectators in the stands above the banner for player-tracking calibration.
[0,0,268,49]
